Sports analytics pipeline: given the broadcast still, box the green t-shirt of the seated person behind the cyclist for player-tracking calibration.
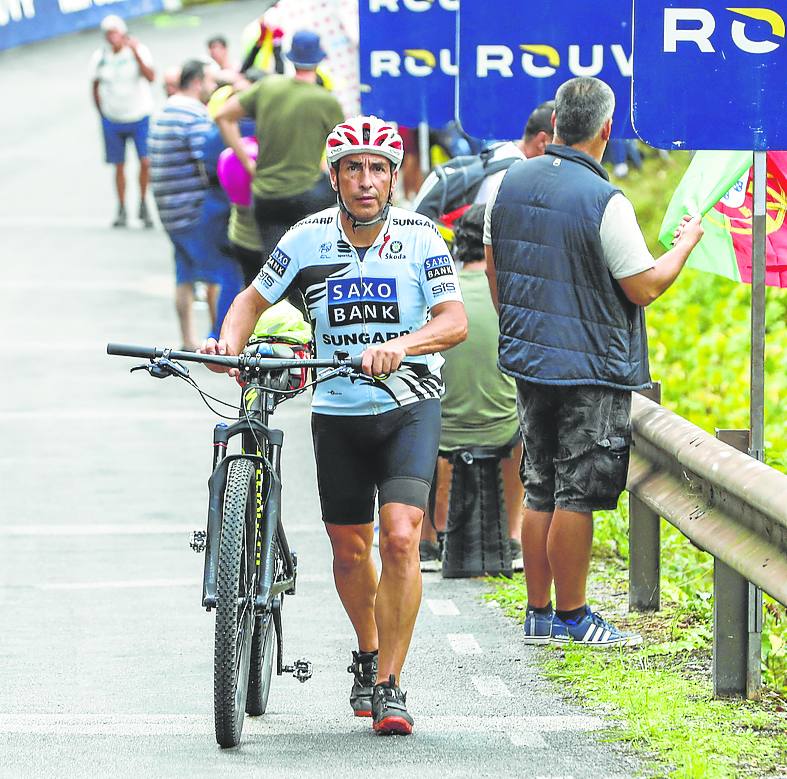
[440,271,519,451]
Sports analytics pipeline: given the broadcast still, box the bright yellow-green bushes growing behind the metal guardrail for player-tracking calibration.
[620,153,787,691]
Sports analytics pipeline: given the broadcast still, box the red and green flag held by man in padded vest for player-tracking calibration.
[659,151,787,288]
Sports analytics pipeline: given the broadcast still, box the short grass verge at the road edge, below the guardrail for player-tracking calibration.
[484,558,787,779]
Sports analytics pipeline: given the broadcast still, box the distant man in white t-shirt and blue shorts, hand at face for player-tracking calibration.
[90,15,155,227]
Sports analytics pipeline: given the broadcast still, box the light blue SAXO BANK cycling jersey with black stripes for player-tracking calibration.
[254,207,462,416]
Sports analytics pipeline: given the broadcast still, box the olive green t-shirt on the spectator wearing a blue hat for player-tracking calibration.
[239,76,344,198]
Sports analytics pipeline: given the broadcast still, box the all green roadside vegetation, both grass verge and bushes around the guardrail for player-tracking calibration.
[486,149,787,777]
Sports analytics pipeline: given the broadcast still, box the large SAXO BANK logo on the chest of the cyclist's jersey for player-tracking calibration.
[328,278,399,327]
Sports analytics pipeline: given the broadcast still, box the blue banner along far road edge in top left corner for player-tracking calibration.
[0,0,164,50]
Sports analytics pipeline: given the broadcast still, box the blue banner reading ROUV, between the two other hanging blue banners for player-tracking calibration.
[458,0,634,139]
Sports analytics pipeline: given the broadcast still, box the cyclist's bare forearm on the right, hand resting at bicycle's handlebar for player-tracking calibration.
[362,300,467,376]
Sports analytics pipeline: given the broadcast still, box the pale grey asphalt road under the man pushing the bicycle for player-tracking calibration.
[0,3,640,779]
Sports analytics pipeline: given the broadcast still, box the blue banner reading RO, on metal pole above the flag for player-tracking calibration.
[633,0,787,151]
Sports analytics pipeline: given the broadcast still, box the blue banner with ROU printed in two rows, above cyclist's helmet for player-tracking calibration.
[359,0,459,127]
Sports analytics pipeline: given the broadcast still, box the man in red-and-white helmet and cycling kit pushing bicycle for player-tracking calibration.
[201,116,467,734]
